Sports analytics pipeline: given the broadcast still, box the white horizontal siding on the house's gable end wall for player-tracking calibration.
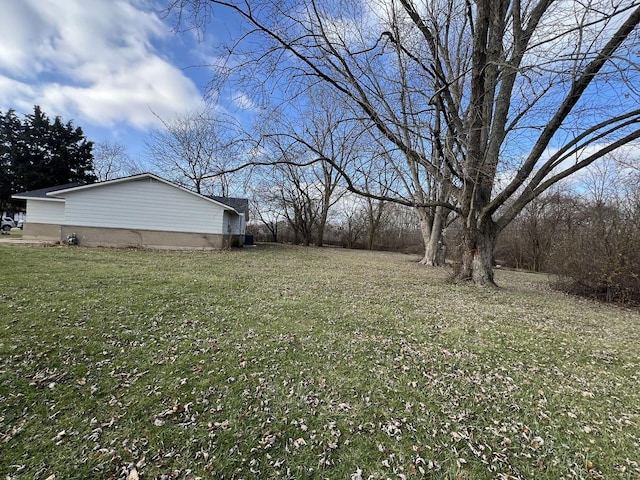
[64,178,227,234]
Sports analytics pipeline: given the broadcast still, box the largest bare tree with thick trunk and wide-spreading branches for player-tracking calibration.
[171,0,640,285]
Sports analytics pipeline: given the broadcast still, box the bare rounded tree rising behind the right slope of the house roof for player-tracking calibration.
[146,110,241,197]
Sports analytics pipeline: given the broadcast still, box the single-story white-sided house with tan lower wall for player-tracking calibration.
[14,173,246,248]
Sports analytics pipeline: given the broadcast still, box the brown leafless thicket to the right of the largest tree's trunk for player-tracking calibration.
[496,159,640,305]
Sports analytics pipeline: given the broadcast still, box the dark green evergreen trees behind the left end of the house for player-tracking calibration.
[0,105,96,209]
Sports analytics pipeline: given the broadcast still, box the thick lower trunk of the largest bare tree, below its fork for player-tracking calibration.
[455,223,498,287]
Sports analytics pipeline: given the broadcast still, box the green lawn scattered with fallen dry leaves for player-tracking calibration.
[0,245,640,480]
